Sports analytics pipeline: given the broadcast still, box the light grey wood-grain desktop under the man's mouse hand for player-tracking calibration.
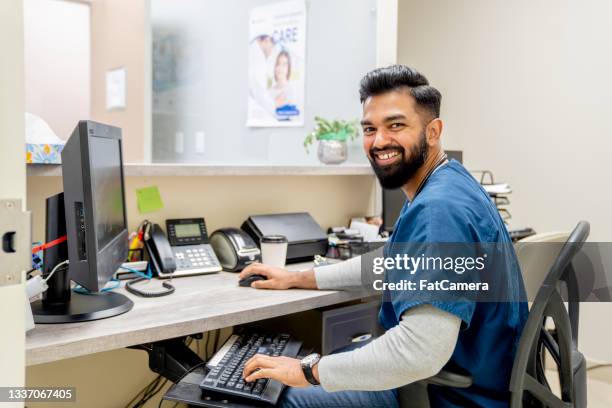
[26,265,371,366]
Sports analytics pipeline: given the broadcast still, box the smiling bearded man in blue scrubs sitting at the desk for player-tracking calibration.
[240,65,528,408]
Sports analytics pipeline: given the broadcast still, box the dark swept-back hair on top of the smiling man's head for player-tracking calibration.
[359,65,442,118]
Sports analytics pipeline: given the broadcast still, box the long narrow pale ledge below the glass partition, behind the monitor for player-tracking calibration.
[28,163,374,177]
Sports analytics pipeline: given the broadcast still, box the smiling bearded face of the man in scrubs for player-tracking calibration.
[361,90,428,189]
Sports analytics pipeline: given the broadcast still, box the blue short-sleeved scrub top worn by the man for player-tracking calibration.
[379,160,528,408]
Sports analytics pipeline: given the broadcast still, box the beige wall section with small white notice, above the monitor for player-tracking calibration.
[91,0,151,163]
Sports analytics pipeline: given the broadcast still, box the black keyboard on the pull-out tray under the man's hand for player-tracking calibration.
[200,333,302,404]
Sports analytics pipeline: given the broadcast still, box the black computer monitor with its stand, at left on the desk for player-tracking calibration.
[32,121,133,323]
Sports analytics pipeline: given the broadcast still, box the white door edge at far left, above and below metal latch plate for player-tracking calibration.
[0,1,26,407]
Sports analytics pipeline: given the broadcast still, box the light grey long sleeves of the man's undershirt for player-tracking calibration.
[314,257,461,392]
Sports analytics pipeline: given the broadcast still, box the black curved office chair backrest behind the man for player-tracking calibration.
[510,221,590,408]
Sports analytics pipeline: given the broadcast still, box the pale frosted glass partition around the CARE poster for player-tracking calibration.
[151,0,377,165]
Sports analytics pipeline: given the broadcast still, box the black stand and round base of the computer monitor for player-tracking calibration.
[31,193,134,323]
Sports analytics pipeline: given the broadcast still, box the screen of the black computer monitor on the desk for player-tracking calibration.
[89,136,127,250]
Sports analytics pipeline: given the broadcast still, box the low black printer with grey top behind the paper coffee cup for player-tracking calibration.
[241,212,327,263]
